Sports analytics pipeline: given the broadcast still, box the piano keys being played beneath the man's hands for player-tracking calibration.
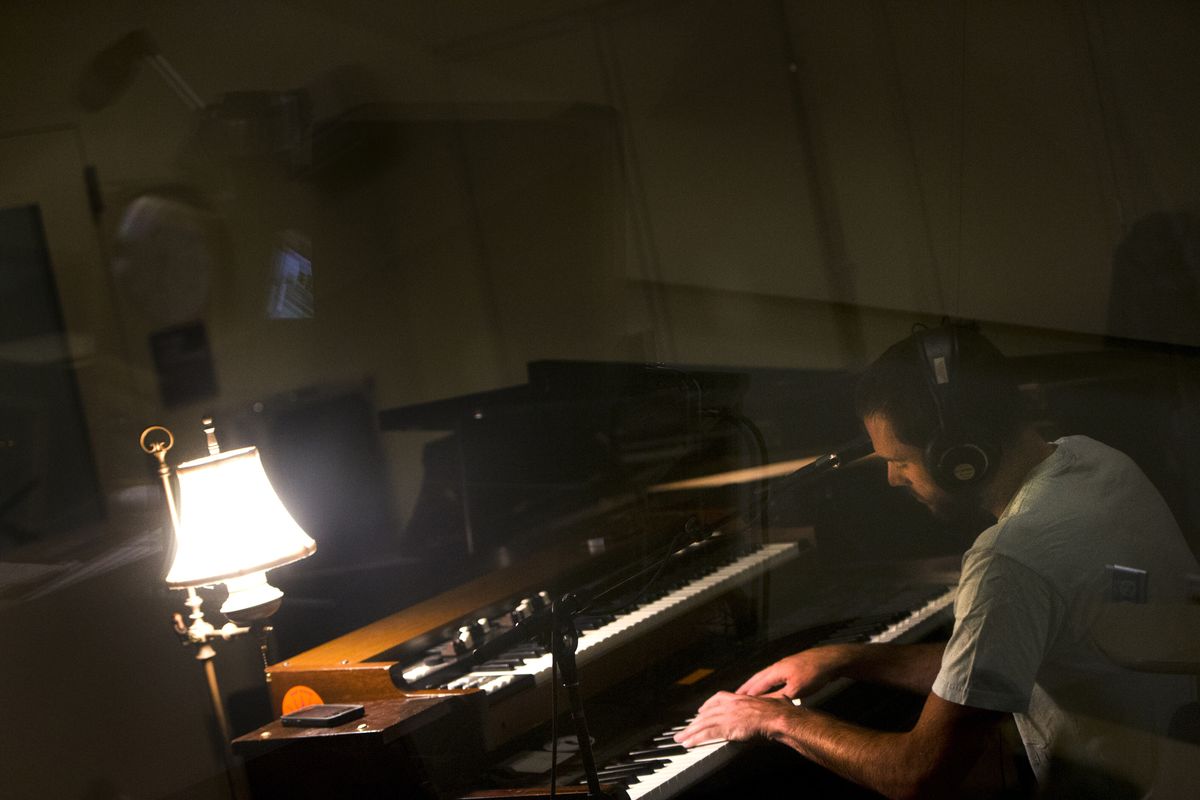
[588,588,956,800]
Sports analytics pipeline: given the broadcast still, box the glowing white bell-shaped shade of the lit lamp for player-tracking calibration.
[167,447,317,589]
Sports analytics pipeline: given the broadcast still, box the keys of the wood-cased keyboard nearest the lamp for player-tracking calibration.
[443,542,799,694]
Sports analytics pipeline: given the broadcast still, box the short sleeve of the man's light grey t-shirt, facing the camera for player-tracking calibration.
[934,548,1055,712]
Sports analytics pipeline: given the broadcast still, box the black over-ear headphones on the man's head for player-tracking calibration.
[913,324,1000,492]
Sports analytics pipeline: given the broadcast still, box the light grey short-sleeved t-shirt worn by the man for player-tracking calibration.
[934,437,1198,784]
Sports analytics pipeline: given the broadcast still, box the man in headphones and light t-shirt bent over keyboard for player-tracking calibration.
[676,329,1196,798]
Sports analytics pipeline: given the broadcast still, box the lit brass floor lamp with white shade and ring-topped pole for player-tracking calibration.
[140,420,317,795]
